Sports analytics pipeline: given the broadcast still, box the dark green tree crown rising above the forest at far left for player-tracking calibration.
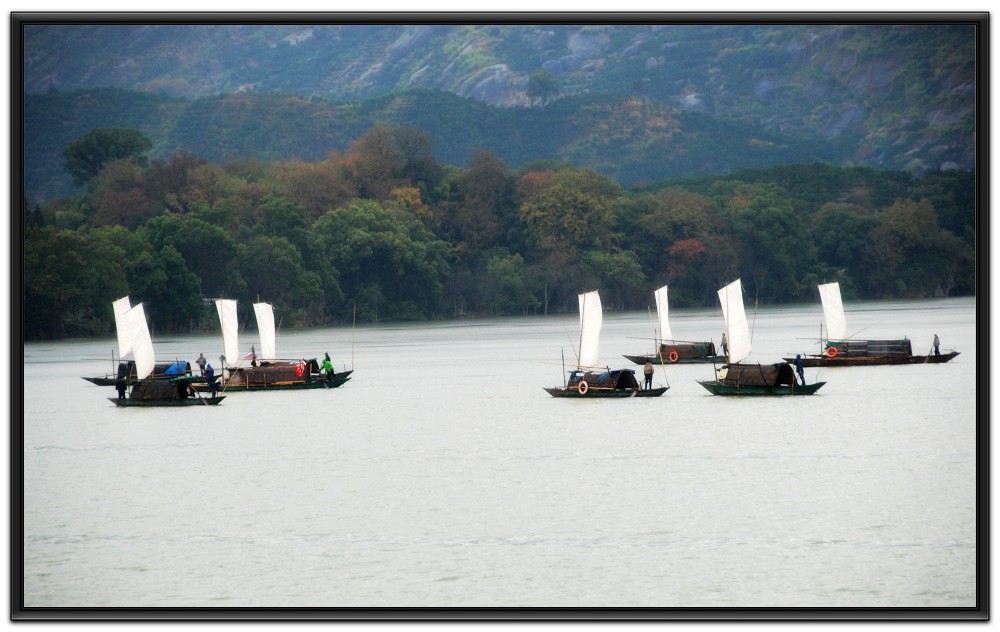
[63,127,153,186]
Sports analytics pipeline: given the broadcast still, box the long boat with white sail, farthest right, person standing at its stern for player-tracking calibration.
[785,282,959,367]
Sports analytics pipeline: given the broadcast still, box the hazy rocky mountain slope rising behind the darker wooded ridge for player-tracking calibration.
[24,23,977,202]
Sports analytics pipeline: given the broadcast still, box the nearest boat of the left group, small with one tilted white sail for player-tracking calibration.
[108,303,225,408]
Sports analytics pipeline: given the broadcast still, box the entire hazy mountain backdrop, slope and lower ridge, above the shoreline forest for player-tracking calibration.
[24,24,977,202]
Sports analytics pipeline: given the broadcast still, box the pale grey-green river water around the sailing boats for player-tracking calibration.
[14,299,986,608]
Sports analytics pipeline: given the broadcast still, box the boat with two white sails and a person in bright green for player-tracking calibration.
[208,299,353,392]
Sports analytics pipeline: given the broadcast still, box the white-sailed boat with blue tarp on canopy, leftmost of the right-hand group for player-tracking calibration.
[545,290,669,399]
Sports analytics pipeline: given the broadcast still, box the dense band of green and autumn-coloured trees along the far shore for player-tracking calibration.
[23,126,976,339]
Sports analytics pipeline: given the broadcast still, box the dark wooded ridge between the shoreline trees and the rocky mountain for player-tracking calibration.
[24,89,856,204]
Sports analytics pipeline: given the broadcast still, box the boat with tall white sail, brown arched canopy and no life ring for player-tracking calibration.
[698,279,826,397]
